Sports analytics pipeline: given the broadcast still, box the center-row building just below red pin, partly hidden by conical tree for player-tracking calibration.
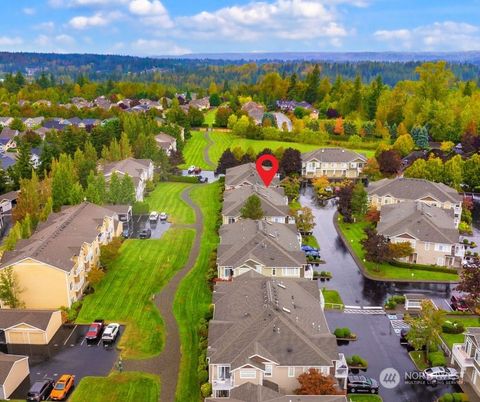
[222,184,295,224]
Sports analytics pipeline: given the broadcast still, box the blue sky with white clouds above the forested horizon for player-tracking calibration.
[0,0,480,56]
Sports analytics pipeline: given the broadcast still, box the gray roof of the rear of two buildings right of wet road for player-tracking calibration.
[367,177,462,203]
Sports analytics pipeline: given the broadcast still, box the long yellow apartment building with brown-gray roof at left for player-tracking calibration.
[0,202,129,309]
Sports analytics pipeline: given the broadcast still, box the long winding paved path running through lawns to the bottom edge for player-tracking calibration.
[124,187,203,402]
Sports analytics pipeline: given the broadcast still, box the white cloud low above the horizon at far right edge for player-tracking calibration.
[374,21,480,51]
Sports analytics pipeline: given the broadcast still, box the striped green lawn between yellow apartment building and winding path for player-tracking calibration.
[77,228,194,358]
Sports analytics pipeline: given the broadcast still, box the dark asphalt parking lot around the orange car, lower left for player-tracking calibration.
[9,325,125,399]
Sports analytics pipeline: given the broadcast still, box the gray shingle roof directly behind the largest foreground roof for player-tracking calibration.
[217,219,306,267]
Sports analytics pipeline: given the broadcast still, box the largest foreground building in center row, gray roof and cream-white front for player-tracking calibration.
[207,271,348,401]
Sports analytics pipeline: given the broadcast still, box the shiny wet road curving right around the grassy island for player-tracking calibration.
[300,188,454,309]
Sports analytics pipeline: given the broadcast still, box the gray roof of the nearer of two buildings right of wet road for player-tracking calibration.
[377,201,459,244]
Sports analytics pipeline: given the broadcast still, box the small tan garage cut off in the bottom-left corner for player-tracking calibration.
[0,352,30,400]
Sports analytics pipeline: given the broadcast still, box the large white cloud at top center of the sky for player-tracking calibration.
[176,0,348,43]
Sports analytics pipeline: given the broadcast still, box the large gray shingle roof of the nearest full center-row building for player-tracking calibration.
[207,271,338,370]
